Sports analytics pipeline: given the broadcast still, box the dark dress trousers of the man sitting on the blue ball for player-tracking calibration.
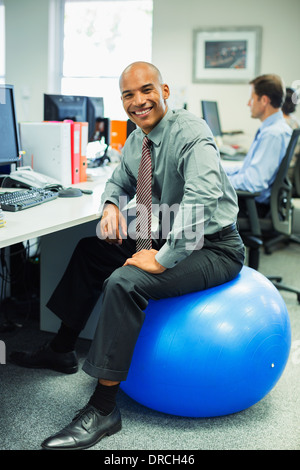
[47,230,244,381]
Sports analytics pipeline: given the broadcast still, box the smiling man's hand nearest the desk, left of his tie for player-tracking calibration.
[100,203,127,245]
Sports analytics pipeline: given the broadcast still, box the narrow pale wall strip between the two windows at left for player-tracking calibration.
[4,0,49,121]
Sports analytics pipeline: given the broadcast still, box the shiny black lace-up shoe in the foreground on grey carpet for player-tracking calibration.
[41,404,122,450]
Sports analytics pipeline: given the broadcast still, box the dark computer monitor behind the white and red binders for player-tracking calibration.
[44,94,104,142]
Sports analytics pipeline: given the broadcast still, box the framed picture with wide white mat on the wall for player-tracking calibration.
[193,26,262,83]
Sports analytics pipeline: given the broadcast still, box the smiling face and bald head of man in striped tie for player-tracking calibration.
[120,62,170,134]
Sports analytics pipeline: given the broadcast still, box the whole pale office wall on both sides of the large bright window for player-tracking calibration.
[4,0,300,140]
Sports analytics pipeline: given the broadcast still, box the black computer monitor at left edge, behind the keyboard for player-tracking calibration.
[0,85,20,167]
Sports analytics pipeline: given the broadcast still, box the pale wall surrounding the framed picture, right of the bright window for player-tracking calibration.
[152,0,300,140]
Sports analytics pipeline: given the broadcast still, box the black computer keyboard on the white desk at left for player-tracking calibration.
[0,188,58,212]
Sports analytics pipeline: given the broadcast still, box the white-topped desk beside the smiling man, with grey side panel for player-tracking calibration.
[0,168,113,339]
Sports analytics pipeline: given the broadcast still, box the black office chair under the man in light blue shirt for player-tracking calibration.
[237,129,300,302]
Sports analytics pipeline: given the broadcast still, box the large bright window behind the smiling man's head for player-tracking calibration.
[61,0,153,120]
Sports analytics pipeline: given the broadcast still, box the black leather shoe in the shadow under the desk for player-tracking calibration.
[9,344,78,374]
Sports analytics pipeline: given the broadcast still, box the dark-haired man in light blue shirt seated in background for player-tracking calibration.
[226,75,292,217]
